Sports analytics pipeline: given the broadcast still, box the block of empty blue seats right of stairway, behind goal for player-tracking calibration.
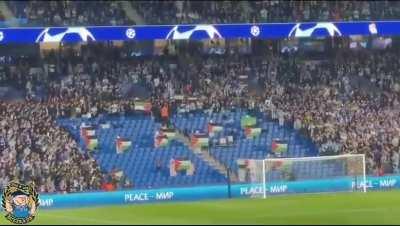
[173,110,313,174]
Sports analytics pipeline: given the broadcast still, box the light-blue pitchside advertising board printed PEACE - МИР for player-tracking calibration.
[39,175,400,209]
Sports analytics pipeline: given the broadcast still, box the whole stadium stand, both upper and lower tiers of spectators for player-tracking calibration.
[0,1,400,193]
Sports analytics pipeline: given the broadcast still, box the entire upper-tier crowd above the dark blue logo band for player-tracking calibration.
[7,0,400,26]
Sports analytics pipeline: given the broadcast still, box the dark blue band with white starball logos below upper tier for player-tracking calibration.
[0,21,400,44]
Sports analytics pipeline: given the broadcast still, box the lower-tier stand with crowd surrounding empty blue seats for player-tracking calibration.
[0,38,400,192]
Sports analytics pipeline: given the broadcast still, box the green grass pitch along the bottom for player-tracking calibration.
[0,190,400,225]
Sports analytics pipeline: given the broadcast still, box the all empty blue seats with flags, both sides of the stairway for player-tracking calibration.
[58,110,320,188]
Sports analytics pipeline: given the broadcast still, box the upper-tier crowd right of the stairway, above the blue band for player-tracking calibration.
[132,0,400,24]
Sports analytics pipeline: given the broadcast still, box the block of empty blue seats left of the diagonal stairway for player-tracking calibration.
[55,116,226,188]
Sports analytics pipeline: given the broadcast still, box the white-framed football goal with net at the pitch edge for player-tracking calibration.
[242,154,367,198]
